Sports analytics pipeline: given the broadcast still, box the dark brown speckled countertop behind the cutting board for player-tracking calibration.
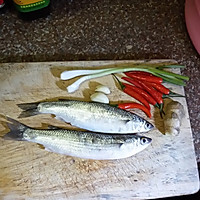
[0,0,200,198]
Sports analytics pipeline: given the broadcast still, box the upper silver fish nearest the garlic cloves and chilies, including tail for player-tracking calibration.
[18,100,154,134]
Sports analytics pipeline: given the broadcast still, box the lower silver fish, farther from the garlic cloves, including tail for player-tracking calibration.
[4,118,152,160]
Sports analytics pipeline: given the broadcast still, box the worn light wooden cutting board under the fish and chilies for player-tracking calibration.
[0,60,199,200]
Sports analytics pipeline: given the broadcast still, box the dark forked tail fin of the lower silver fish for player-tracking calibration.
[3,117,27,141]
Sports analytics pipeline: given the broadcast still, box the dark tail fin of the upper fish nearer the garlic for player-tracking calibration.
[17,103,39,118]
